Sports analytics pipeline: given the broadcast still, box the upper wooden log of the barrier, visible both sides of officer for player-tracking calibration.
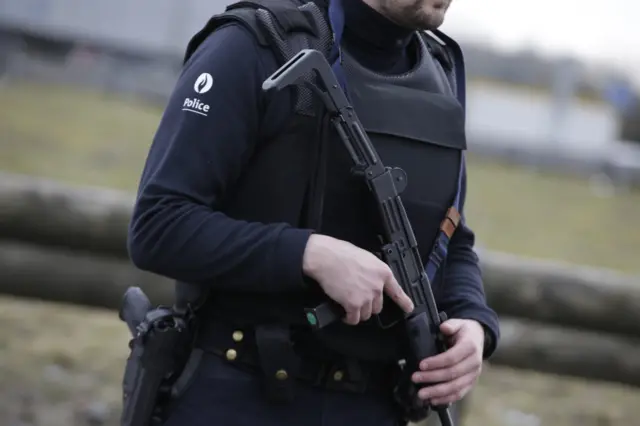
[0,174,640,336]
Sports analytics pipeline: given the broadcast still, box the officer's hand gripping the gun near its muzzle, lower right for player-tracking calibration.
[412,319,484,405]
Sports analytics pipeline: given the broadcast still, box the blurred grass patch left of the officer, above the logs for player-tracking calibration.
[0,84,161,190]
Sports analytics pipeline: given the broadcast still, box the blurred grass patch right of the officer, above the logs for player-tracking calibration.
[467,158,640,274]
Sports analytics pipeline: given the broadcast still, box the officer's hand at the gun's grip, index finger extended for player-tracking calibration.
[302,234,413,325]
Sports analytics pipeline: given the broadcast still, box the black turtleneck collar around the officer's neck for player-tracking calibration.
[342,0,415,74]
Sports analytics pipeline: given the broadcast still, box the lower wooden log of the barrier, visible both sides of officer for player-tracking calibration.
[0,243,640,387]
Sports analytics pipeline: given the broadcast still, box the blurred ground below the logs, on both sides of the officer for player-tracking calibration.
[0,298,640,426]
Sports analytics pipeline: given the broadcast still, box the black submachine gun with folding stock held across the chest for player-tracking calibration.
[262,49,453,426]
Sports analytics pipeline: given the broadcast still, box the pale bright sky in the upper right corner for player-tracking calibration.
[442,0,640,82]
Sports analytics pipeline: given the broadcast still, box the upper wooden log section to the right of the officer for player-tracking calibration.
[480,252,640,337]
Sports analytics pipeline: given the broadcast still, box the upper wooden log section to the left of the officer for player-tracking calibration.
[0,173,134,257]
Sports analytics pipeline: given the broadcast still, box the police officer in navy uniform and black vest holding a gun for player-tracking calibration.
[129,0,499,426]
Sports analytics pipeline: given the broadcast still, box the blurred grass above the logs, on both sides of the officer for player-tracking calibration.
[0,80,640,274]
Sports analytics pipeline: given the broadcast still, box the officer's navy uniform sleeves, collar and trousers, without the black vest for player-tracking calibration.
[129,0,499,426]
